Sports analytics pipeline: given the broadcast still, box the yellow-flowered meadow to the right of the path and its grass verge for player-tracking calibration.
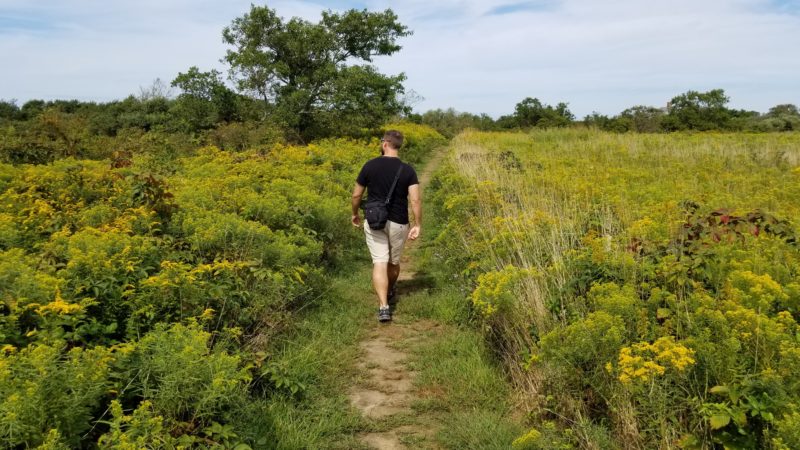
[429,129,800,449]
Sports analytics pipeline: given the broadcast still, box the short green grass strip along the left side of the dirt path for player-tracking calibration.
[233,264,373,449]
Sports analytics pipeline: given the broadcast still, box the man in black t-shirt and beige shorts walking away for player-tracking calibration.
[351,130,422,322]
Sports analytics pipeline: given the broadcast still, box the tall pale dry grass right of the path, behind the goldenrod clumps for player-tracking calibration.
[434,130,800,448]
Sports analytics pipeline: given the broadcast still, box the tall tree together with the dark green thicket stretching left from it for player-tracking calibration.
[0,5,411,163]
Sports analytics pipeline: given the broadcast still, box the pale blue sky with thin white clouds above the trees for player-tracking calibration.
[0,0,800,118]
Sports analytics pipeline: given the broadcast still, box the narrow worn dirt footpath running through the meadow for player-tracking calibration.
[349,148,446,450]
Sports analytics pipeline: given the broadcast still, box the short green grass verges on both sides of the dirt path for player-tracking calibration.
[242,266,523,449]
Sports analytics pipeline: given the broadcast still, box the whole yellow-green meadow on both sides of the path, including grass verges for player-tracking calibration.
[0,123,800,450]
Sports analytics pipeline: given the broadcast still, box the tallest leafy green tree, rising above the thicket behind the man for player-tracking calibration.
[222,5,411,139]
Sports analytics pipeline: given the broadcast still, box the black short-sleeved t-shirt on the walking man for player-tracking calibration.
[356,156,419,224]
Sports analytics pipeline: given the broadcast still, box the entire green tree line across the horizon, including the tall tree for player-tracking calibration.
[0,6,800,167]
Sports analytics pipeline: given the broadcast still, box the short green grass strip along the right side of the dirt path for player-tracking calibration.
[401,270,524,449]
